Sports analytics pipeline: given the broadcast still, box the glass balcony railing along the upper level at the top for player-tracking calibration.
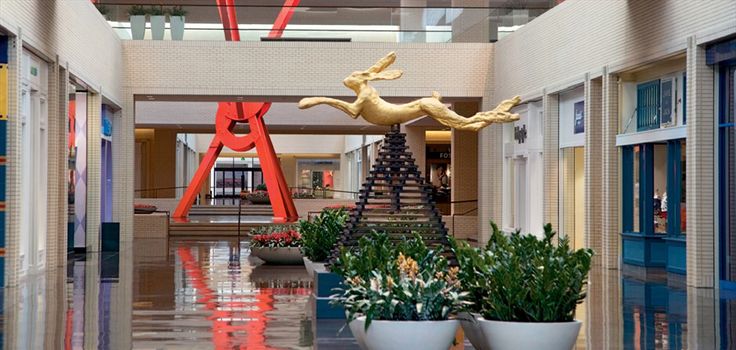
[98,0,553,43]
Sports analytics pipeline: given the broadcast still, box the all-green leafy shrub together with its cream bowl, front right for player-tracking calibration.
[455,224,593,350]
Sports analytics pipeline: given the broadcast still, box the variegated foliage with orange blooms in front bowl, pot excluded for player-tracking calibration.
[331,234,469,329]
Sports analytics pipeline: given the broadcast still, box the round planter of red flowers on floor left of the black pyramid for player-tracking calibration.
[250,226,303,265]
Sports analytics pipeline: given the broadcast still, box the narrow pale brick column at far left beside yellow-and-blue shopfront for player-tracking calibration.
[5,34,23,288]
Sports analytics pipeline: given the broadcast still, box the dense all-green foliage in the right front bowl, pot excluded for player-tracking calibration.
[454,223,593,322]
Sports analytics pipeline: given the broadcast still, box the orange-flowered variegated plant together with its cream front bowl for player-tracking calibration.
[332,234,467,350]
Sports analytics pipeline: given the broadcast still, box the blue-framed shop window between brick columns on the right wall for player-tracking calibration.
[621,139,687,273]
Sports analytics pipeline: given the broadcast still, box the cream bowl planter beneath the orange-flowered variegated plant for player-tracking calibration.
[349,317,460,350]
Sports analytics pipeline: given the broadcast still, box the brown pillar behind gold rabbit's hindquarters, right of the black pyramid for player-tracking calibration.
[450,102,478,216]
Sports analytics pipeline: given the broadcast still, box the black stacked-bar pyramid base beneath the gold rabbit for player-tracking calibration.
[330,125,449,262]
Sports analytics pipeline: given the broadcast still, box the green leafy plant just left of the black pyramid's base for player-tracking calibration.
[299,209,348,261]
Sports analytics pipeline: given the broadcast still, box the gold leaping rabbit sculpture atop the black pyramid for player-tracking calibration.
[299,52,521,131]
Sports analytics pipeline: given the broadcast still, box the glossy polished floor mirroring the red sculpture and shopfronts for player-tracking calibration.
[0,240,736,350]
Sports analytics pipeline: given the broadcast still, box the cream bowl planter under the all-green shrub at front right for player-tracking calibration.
[478,320,582,350]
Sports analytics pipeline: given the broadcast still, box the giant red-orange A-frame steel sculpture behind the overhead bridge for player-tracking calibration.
[173,0,299,222]
